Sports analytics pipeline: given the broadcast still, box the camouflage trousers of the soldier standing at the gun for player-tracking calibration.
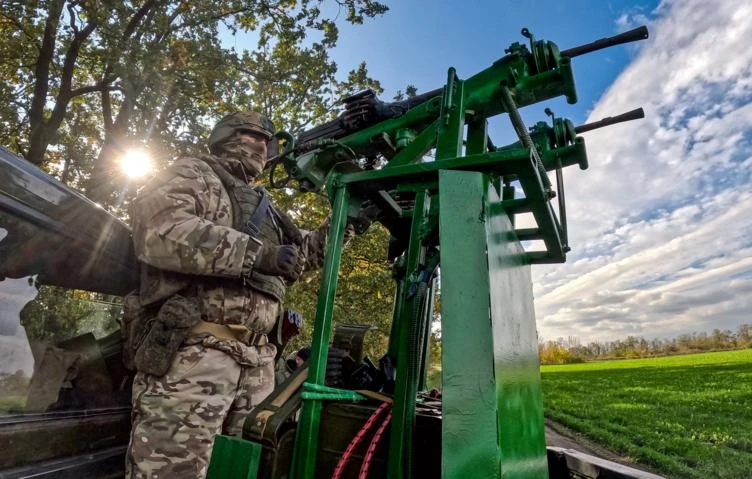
[125,338,276,479]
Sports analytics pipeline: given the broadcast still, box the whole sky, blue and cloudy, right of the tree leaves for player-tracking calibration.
[333,0,752,342]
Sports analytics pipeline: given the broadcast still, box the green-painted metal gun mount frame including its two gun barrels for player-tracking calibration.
[238,28,647,479]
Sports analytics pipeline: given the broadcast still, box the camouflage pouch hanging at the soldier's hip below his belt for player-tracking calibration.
[129,294,201,376]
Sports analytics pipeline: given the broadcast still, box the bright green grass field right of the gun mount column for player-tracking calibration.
[541,349,752,479]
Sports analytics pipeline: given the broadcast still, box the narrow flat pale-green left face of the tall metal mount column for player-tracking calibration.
[439,171,501,478]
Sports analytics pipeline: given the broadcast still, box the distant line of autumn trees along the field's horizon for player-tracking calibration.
[538,324,752,364]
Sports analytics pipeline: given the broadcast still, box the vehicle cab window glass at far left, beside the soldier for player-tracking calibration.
[0,242,128,415]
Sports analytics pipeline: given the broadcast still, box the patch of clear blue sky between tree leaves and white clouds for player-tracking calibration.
[333,1,655,127]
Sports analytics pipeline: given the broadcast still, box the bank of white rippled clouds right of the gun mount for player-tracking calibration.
[533,0,752,341]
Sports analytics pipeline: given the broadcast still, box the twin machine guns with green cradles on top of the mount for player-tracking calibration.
[270,27,648,262]
